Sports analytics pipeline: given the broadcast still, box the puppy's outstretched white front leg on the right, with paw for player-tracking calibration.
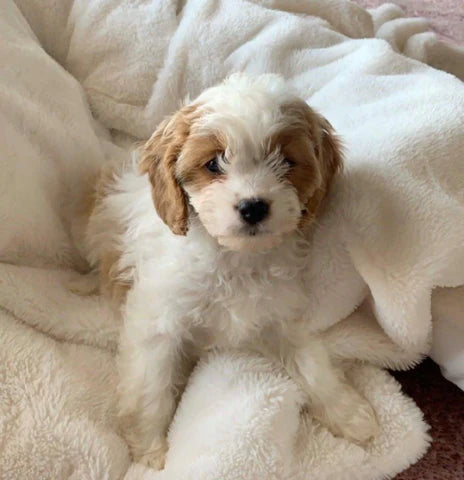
[284,338,379,443]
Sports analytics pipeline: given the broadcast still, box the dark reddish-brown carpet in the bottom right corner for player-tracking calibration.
[393,360,464,480]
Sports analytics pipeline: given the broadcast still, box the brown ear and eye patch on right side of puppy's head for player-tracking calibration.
[270,100,343,226]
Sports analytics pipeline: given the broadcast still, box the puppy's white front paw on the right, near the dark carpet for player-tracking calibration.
[321,389,380,445]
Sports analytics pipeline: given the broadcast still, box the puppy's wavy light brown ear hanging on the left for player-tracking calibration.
[139,107,191,235]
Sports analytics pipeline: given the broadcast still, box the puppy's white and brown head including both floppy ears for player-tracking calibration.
[140,75,342,250]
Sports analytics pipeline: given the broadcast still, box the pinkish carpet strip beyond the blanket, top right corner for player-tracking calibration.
[355,0,464,43]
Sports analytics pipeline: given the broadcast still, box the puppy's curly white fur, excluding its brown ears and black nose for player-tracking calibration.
[87,75,377,468]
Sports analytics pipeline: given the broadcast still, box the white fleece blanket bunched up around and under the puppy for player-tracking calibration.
[0,0,464,480]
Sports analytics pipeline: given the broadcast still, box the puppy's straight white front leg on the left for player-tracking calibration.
[119,328,181,469]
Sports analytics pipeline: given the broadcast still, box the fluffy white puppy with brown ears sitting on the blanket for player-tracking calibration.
[78,74,377,468]
